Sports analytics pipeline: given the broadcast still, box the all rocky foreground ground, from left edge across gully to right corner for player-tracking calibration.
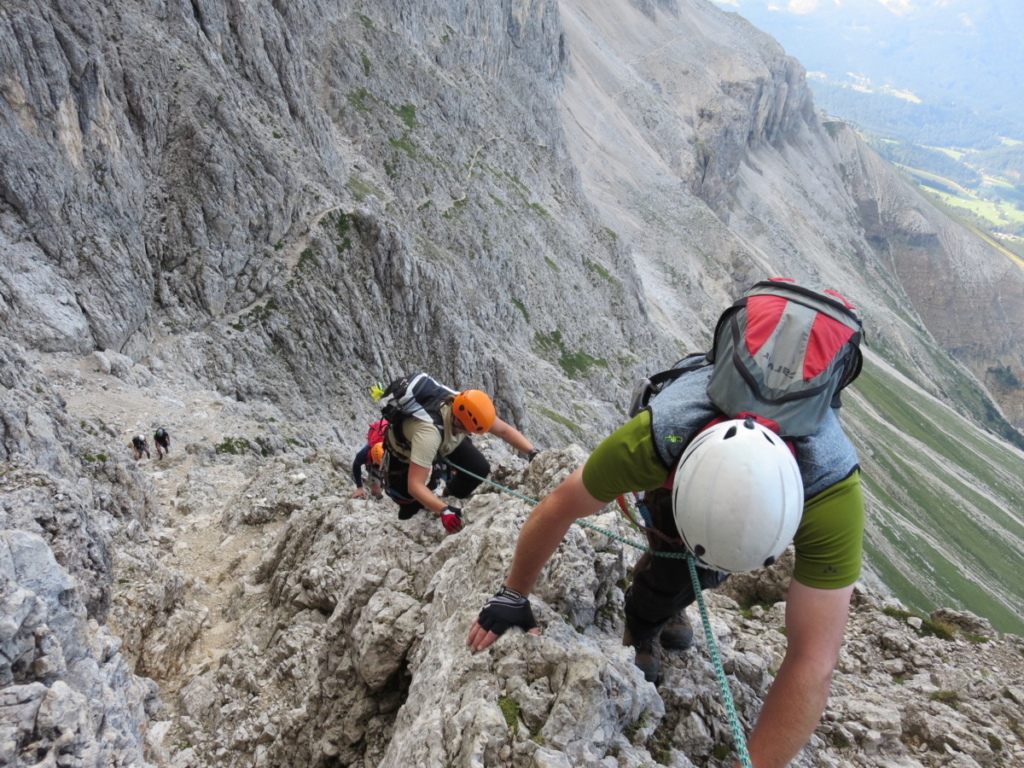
[0,342,1024,768]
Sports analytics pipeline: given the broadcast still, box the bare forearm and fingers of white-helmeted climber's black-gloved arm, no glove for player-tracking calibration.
[467,467,605,652]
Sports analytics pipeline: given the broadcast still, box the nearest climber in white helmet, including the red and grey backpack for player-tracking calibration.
[467,283,864,766]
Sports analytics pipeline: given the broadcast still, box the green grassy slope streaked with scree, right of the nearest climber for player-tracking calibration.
[844,362,1024,635]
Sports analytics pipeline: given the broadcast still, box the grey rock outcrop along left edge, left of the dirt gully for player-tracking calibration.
[0,344,177,766]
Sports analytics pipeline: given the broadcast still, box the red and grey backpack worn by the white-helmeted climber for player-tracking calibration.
[630,278,863,437]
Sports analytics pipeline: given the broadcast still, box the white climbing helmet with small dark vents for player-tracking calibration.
[672,419,804,572]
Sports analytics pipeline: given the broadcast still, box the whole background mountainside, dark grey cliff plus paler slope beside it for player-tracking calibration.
[0,0,1024,440]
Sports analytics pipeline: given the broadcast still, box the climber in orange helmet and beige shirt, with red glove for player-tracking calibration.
[381,374,538,534]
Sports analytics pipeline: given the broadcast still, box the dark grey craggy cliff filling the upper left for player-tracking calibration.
[0,0,654,444]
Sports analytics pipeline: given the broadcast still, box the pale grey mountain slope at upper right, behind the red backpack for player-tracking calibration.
[561,2,1024,431]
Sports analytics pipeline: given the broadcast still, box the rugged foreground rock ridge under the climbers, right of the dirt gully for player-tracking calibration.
[153,451,1024,768]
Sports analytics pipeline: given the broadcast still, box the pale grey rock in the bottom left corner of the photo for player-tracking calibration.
[0,530,160,766]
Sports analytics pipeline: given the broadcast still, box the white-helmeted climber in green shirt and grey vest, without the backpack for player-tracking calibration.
[467,360,864,768]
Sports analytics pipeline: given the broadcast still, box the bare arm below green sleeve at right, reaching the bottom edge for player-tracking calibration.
[737,582,853,768]
